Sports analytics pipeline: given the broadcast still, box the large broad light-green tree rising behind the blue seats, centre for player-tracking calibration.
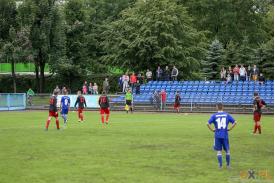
[102,0,207,78]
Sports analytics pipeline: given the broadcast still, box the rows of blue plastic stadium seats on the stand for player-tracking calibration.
[112,80,274,106]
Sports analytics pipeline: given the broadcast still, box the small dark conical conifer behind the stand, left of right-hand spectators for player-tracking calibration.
[202,39,224,80]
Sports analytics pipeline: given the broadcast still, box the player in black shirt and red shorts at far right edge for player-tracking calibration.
[253,92,266,134]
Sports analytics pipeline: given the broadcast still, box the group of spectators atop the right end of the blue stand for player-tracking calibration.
[220,64,265,84]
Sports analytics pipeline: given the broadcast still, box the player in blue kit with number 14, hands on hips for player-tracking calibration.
[207,103,237,168]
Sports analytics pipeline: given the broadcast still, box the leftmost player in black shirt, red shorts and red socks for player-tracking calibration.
[45,91,59,131]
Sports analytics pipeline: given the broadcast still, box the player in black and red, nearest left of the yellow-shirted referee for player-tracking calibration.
[98,91,110,125]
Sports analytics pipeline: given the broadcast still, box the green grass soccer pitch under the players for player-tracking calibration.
[0,111,274,183]
